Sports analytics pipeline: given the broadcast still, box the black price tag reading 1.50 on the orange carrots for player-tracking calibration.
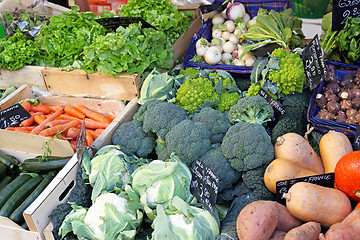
[0,103,31,129]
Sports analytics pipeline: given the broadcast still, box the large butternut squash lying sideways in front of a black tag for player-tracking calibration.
[283,182,351,227]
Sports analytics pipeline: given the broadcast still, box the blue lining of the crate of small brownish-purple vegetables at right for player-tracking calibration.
[307,61,360,137]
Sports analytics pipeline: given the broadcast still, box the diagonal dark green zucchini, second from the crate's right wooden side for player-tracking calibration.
[0,175,44,217]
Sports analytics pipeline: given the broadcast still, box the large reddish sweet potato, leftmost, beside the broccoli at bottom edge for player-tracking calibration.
[236,200,278,240]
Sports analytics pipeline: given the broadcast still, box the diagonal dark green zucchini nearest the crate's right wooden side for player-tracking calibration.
[9,171,55,225]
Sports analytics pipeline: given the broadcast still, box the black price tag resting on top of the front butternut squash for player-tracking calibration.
[276,173,335,204]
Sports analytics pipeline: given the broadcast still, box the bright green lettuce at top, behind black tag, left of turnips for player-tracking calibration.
[120,0,192,44]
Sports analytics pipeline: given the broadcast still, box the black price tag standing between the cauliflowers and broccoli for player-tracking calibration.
[190,160,219,214]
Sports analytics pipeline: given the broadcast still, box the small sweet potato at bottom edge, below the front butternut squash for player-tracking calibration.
[284,222,321,240]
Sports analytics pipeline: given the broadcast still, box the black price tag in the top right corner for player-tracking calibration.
[331,0,360,31]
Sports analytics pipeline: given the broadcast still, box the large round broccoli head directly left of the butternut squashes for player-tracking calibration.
[221,122,274,171]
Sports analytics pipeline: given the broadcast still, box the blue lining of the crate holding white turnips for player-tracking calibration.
[183,0,292,74]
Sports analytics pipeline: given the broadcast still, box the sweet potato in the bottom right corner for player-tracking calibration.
[319,209,360,240]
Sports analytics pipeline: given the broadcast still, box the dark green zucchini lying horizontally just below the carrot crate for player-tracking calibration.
[19,158,70,173]
